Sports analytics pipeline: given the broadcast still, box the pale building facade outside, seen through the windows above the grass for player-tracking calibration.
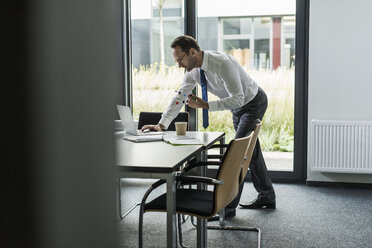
[131,0,295,70]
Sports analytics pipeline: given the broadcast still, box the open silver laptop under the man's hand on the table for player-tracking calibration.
[116,105,164,142]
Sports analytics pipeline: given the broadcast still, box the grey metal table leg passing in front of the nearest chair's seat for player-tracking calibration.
[166,174,177,248]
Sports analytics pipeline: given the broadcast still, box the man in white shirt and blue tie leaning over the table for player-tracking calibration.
[142,36,275,220]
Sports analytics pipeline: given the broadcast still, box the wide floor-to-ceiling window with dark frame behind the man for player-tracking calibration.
[123,0,309,180]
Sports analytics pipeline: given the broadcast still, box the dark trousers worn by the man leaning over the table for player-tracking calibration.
[227,88,274,208]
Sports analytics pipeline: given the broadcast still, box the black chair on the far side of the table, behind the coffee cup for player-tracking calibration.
[119,112,189,219]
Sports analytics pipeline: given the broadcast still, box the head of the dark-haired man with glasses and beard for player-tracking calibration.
[171,35,203,71]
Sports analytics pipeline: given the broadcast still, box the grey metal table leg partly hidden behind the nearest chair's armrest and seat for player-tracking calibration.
[197,151,207,247]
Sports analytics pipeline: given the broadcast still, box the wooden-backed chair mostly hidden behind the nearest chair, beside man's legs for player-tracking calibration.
[182,119,262,247]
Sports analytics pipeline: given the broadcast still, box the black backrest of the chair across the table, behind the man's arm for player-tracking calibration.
[138,112,189,131]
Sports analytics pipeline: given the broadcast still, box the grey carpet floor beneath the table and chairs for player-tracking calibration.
[119,179,372,248]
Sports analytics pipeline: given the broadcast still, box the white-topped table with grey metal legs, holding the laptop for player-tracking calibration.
[116,132,225,247]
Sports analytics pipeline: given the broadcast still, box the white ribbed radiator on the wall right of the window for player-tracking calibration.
[310,120,372,174]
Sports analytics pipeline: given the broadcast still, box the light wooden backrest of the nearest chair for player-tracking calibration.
[214,133,253,214]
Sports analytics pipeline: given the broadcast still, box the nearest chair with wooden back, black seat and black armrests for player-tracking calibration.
[139,134,253,247]
